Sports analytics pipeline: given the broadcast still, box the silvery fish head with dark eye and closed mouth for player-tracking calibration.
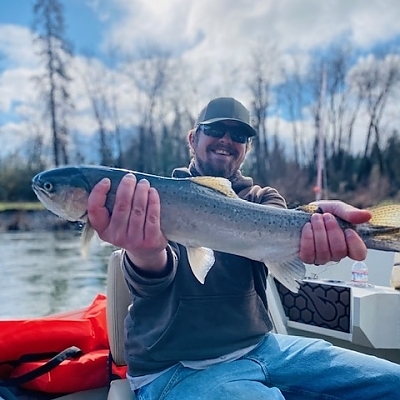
[32,167,91,222]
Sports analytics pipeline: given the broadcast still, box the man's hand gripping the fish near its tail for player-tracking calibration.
[299,200,371,265]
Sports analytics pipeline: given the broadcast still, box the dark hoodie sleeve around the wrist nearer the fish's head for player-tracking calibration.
[122,243,178,298]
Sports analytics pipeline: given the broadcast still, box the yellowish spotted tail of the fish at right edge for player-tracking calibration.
[359,204,400,252]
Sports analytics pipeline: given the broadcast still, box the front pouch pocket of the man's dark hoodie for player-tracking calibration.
[147,291,270,362]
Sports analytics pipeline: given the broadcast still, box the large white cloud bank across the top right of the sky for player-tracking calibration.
[101,0,400,59]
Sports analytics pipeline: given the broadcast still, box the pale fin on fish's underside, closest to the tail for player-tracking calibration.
[266,258,306,293]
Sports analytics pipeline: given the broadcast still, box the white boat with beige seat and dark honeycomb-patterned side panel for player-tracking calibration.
[0,250,400,400]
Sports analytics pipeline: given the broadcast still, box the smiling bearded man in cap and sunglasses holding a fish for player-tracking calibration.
[88,98,400,400]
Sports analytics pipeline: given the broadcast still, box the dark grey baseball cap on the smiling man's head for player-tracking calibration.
[195,97,257,136]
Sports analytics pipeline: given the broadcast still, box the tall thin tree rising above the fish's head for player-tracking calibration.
[33,0,73,166]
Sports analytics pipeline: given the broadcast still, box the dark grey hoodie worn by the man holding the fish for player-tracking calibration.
[123,165,286,376]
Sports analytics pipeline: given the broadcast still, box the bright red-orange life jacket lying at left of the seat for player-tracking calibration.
[0,294,126,393]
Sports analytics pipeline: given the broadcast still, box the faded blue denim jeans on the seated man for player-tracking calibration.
[137,334,400,400]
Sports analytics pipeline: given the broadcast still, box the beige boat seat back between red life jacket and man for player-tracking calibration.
[107,250,132,366]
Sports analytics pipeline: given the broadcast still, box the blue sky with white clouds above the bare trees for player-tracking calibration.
[0,0,400,159]
